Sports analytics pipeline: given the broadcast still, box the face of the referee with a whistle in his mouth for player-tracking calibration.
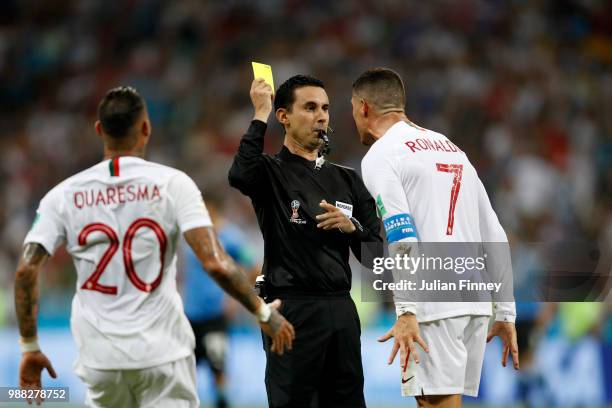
[285,86,329,151]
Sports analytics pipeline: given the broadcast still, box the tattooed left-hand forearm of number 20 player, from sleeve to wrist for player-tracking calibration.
[15,244,49,338]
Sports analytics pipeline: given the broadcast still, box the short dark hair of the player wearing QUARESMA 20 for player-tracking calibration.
[98,86,145,138]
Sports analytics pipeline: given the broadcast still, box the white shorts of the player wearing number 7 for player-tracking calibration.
[402,316,489,397]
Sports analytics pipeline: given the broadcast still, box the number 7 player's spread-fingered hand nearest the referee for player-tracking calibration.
[378,313,429,370]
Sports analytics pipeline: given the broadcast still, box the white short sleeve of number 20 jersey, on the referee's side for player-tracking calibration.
[168,173,212,232]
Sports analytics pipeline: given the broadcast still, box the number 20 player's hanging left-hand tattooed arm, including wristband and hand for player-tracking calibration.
[15,243,57,403]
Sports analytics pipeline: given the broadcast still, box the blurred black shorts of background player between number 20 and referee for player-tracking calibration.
[189,316,228,374]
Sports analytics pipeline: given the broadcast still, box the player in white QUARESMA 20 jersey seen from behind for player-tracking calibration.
[15,87,295,407]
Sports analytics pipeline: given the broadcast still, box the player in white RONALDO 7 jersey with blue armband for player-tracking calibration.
[351,68,519,407]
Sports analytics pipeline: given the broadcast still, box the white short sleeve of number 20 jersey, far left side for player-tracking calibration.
[24,187,66,255]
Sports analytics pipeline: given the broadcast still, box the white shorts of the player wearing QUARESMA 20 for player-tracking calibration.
[75,354,200,408]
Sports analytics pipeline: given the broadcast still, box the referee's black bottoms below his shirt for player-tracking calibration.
[263,295,366,408]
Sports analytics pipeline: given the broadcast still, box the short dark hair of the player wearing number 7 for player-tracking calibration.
[353,67,406,110]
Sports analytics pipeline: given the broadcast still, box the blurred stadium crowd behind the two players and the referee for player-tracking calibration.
[0,0,612,406]
